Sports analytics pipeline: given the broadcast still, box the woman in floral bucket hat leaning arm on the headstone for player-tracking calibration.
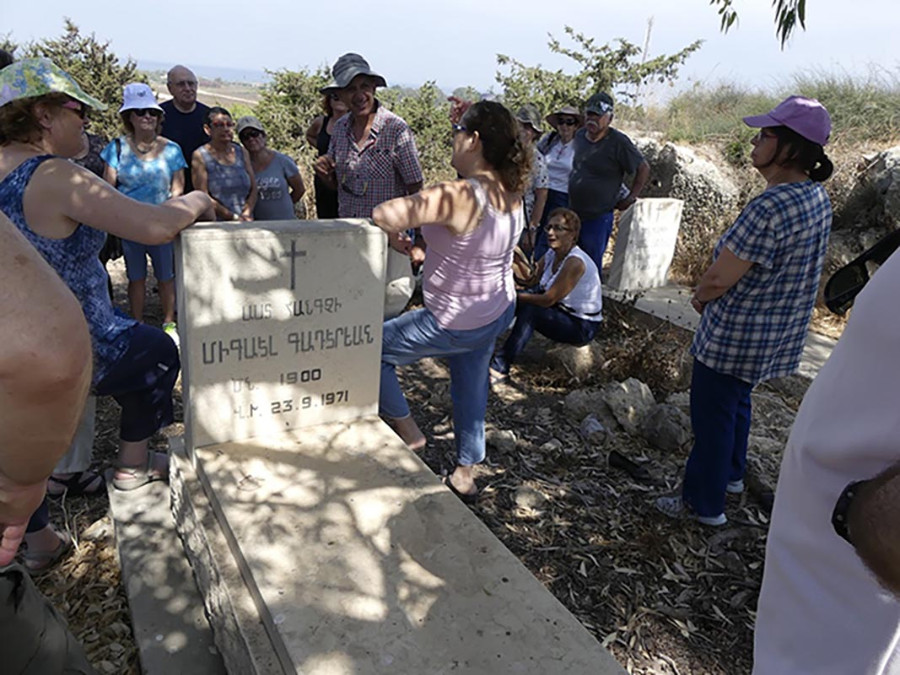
[0,59,212,570]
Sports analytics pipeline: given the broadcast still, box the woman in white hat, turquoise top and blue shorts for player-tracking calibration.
[100,82,187,344]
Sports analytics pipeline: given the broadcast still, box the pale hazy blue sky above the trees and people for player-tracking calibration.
[0,0,900,98]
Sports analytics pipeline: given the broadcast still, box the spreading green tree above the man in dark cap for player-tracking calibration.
[497,26,703,111]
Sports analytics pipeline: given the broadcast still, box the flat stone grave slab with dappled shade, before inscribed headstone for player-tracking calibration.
[183,418,624,675]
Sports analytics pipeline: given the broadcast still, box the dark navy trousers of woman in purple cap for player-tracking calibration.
[681,359,753,517]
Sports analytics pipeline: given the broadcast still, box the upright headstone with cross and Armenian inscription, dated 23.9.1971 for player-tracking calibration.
[176,221,386,449]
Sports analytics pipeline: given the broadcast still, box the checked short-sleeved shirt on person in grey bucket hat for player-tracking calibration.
[328,103,422,218]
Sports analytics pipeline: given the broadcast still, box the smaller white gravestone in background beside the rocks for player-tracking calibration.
[606,199,684,291]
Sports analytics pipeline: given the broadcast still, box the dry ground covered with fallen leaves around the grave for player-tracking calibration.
[38,261,805,675]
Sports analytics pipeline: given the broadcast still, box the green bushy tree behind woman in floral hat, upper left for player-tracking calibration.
[16,19,147,138]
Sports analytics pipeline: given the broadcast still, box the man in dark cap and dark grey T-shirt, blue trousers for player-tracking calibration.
[569,92,650,270]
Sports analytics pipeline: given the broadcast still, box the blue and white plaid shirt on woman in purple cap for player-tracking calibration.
[691,181,831,384]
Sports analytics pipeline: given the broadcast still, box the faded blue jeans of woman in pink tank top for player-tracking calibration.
[378,304,515,466]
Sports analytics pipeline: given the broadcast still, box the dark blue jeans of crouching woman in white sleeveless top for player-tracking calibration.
[491,302,600,373]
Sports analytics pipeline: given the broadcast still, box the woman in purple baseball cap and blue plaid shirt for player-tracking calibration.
[656,96,834,526]
